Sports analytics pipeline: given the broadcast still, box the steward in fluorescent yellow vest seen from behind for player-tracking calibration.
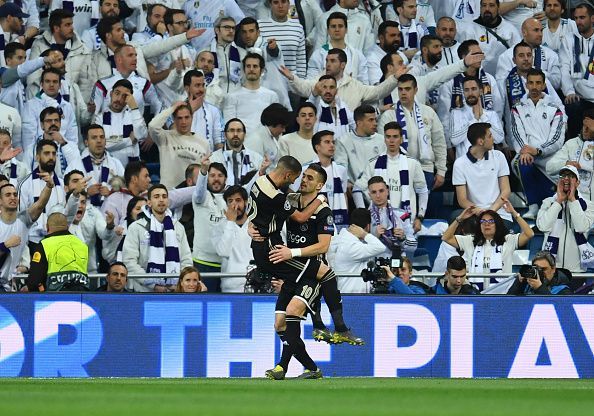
[27,212,89,292]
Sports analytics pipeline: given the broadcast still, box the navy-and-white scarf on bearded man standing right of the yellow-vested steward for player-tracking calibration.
[144,206,180,273]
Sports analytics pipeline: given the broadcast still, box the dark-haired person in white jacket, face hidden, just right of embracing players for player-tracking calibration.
[328,208,386,293]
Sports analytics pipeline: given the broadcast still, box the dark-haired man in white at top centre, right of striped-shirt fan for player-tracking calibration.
[307,12,369,84]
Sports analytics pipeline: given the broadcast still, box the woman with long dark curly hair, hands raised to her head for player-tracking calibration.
[441,198,534,274]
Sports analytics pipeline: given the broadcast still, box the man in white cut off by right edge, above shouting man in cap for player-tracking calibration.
[546,109,594,201]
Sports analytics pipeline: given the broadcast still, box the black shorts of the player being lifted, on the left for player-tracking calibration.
[252,241,322,283]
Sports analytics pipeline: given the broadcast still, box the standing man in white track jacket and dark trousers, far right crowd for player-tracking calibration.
[511,68,565,219]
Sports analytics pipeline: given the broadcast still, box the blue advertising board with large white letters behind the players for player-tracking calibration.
[0,294,594,378]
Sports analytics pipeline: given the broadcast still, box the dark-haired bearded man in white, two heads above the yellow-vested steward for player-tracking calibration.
[23,107,80,178]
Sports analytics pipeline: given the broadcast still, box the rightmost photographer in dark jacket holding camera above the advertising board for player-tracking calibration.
[507,250,573,295]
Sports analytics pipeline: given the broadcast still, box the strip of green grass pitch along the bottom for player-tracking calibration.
[0,378,594,416]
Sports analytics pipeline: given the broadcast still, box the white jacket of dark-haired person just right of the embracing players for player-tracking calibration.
[328,228,386,293]
